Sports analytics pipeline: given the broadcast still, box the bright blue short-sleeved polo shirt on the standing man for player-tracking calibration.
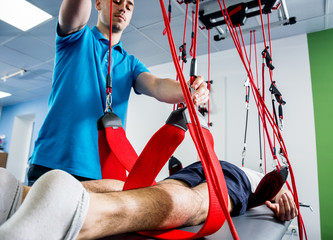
[31,26,148,179]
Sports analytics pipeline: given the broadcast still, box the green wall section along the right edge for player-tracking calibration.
[303,29,333,240]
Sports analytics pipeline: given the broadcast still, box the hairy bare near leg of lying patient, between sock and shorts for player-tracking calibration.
[78,180,231,239]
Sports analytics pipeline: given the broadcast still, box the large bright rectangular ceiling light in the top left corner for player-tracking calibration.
[0,0,52,31]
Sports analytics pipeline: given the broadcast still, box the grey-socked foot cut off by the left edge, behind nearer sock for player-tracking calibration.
[0,168,23,225]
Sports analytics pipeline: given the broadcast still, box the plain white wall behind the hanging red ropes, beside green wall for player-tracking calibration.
[127,35,320,239]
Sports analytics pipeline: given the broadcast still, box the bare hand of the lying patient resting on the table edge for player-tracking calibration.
[266,189,298,221]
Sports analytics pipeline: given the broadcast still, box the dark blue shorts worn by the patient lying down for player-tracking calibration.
[167,161,251,216]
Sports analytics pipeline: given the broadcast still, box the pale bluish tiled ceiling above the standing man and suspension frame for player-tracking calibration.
[0,0,333,106]
